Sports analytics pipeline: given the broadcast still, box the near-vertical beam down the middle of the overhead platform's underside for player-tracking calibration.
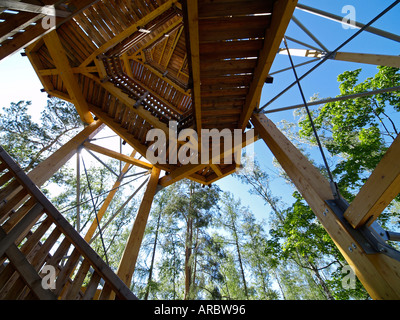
[186,0,202,135]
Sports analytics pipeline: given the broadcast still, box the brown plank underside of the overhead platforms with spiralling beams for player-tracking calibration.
[0,0,297,185]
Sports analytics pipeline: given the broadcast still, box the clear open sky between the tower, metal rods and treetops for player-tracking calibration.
[0,0,400,224]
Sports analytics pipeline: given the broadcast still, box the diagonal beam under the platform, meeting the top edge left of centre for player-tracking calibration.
[81,0,178,67]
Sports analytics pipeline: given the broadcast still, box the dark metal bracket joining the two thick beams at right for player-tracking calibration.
[325,198,400,261]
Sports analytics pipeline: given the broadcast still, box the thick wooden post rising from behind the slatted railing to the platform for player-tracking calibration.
[117,167,160,287]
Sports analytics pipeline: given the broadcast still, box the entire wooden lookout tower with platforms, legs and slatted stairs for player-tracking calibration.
[0,0,400,299]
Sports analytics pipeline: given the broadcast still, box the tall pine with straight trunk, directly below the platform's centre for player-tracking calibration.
[139,180,220,300]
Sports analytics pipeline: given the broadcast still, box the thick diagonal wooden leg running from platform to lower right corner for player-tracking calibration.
[251,114,400,300]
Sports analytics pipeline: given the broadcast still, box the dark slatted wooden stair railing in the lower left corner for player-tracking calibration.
[0,147,137,300]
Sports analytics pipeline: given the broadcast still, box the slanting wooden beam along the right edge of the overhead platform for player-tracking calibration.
[239,0,297,130]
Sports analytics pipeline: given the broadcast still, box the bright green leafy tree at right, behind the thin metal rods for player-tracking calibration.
[299,67,400,205]
